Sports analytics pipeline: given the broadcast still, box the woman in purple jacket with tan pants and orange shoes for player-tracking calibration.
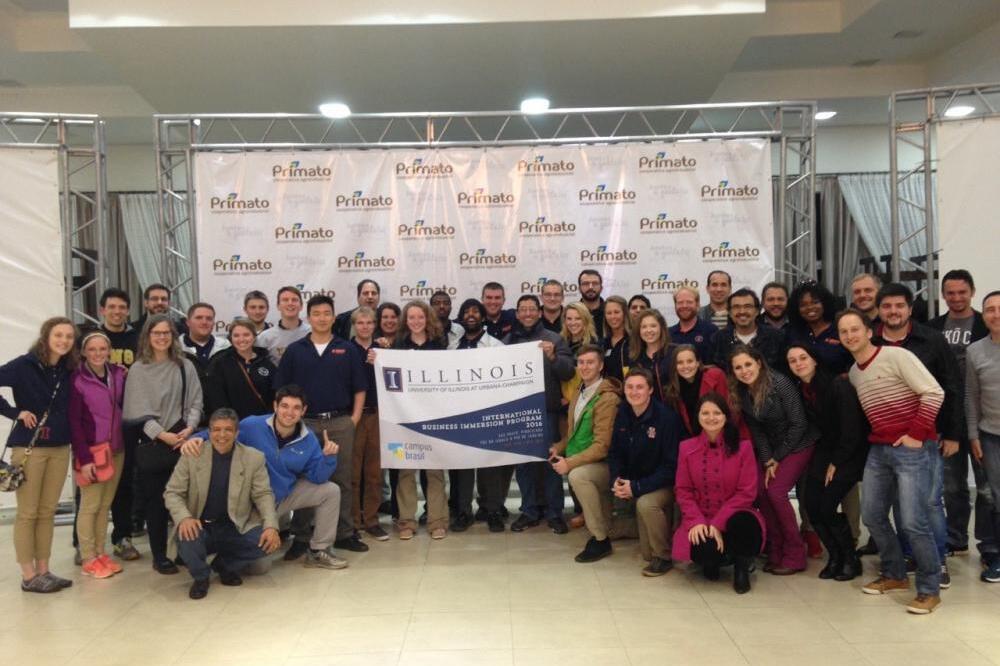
[69,331,125,578]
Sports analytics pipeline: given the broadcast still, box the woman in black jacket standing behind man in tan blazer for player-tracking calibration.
[205,318,275,419]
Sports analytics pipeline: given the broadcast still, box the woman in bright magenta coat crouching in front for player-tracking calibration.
[673,393,764,594]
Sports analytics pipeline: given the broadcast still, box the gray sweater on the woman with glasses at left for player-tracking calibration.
[122,359,202,439]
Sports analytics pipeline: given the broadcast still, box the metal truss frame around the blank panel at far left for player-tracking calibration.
[0,113,108,323]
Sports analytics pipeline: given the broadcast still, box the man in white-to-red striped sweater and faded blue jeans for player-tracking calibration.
[837,310,944,615]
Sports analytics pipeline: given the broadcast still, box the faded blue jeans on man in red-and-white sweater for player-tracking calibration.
[861,441,941,595]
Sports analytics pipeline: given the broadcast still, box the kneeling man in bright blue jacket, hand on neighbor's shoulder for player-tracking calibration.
[181,384,347,569]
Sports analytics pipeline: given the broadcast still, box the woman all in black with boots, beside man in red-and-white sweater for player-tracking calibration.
[787,344,868,581]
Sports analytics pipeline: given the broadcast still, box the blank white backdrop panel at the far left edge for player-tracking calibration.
[0,148,66,508]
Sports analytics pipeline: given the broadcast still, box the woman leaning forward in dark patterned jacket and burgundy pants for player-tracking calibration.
[729,344,818,576]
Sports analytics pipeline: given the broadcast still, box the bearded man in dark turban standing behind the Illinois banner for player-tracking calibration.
[448,298,504,532]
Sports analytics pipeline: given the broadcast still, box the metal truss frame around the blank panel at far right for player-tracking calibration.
[889,83,1000,317]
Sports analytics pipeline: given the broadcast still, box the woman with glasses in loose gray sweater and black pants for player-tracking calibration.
[123,315,202,574]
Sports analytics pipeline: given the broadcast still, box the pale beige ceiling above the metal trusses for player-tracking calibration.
[0,0,1000,143]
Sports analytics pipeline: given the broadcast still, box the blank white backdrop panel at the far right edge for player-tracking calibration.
[937,118,1000,304]
